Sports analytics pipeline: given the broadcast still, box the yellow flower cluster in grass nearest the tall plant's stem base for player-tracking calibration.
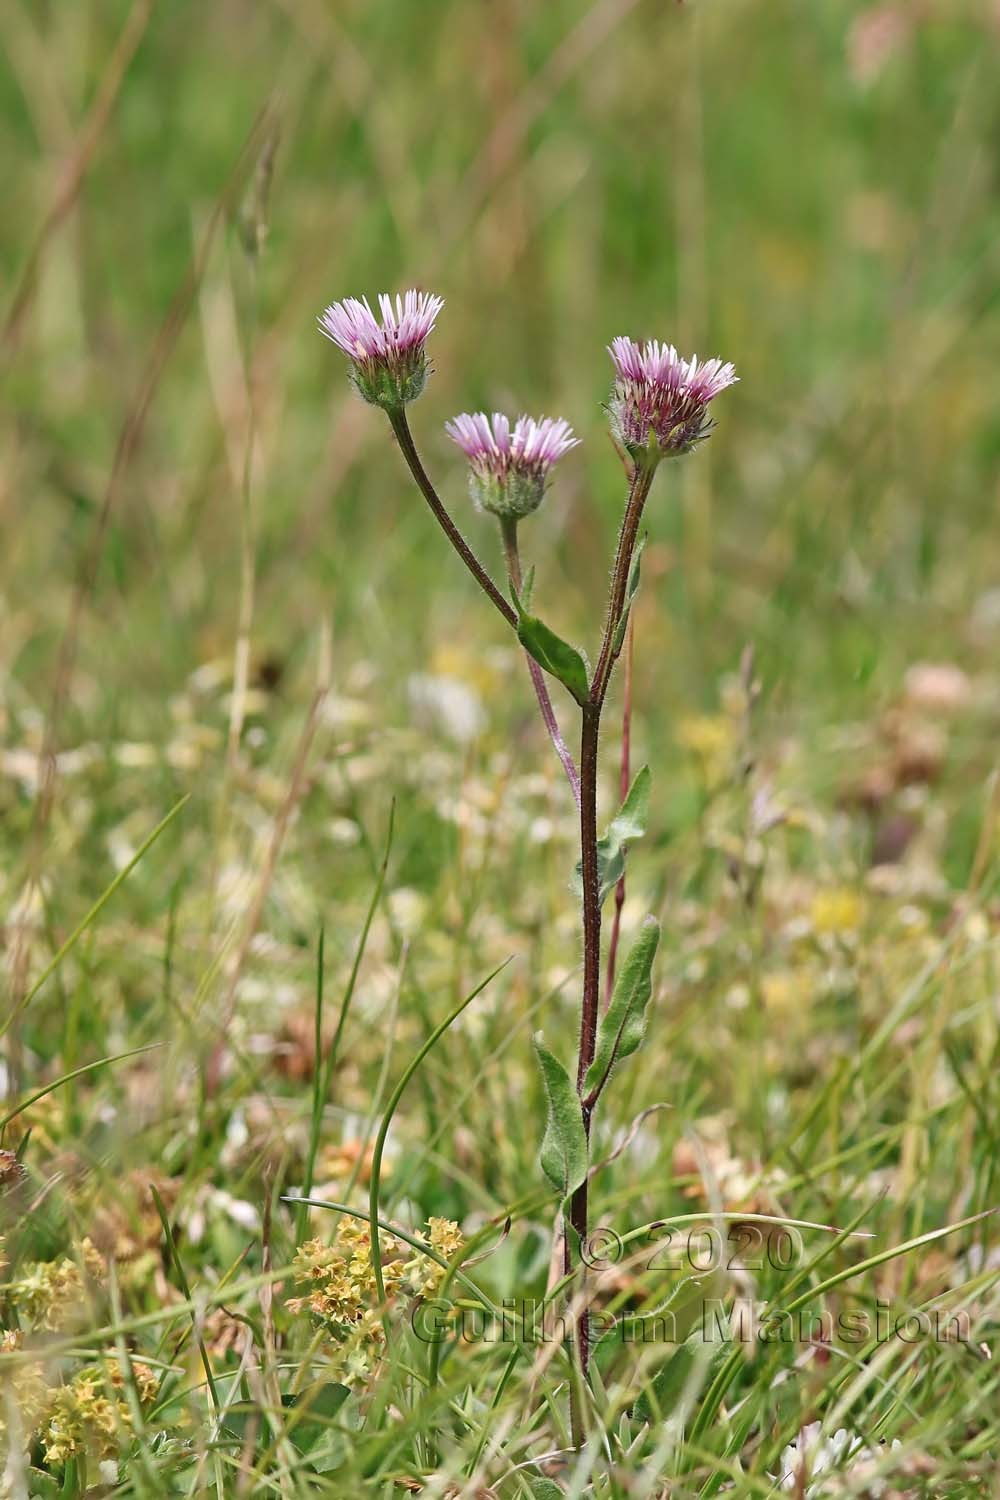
[288,1218,463,1385]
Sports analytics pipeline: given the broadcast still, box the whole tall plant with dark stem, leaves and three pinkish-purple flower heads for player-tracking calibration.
[319,290,736,1443]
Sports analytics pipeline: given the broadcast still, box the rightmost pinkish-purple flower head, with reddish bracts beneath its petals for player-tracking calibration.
[607,338,738,462]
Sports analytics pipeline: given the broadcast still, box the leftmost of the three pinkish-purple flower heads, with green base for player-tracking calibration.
[319,288,444,407]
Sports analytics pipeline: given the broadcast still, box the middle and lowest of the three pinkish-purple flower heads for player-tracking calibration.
[445,411,579,521]
